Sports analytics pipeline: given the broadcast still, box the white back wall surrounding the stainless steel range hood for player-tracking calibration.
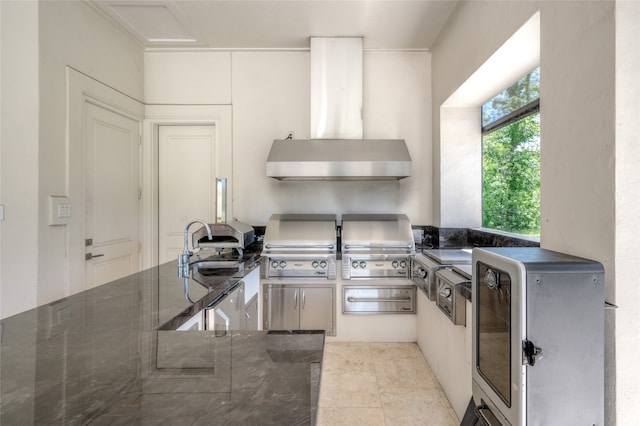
[145,51,431,225]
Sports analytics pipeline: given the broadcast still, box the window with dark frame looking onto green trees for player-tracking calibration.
[482,68,540,236]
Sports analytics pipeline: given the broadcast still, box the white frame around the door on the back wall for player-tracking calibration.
[140,105,233,269]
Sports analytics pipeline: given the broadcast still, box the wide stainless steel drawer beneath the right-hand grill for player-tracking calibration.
[342,285,416,314]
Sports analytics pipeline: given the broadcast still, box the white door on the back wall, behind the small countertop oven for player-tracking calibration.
[158,126,216,263]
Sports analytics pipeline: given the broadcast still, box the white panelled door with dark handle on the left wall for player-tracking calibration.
[84,103,140,288]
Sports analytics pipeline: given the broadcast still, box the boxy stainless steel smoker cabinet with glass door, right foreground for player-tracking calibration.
[465,248,604,425]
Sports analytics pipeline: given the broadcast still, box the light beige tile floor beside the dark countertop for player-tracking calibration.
[317,342,460,426]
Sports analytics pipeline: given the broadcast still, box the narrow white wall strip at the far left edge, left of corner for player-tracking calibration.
[0,1,39,318]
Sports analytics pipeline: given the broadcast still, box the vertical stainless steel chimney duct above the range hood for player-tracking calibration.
[310,37,362,139]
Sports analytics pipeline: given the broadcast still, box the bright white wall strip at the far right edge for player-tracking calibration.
[608,1,640,425]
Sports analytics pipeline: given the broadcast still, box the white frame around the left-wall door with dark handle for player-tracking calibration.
[66,66,144,294]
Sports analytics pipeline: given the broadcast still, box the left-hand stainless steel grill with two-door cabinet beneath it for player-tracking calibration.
[261,214,337,335]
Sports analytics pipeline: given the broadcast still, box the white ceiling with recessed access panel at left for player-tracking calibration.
[85,0,457,49]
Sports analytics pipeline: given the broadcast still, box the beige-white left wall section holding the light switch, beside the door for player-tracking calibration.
[38,1,144,305]
